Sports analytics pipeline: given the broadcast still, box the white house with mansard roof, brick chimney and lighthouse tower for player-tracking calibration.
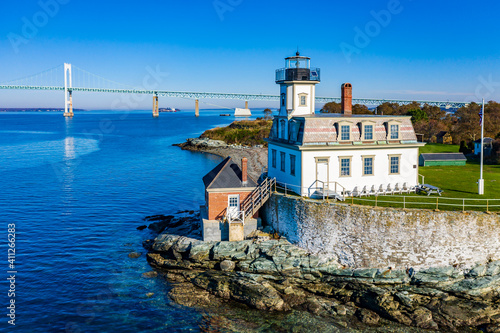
[268,52,424,199]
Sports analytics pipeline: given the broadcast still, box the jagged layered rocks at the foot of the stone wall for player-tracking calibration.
[145,232,500,333]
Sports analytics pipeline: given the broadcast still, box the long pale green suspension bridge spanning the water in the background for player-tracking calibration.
[0,64,466,117]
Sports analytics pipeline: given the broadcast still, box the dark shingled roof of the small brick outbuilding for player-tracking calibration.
[203,156,257,189]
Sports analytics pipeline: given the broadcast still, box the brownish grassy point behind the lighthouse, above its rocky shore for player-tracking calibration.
[201,119,273,146]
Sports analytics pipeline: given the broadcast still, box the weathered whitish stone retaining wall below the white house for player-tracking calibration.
[263,194,500,269]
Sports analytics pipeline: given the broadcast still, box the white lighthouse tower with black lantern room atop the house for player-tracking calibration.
[276,51,320,119]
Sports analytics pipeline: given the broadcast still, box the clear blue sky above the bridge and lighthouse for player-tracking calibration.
[0,0,500,109]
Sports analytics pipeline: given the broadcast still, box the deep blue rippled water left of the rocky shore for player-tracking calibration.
[0,111,258,332]
